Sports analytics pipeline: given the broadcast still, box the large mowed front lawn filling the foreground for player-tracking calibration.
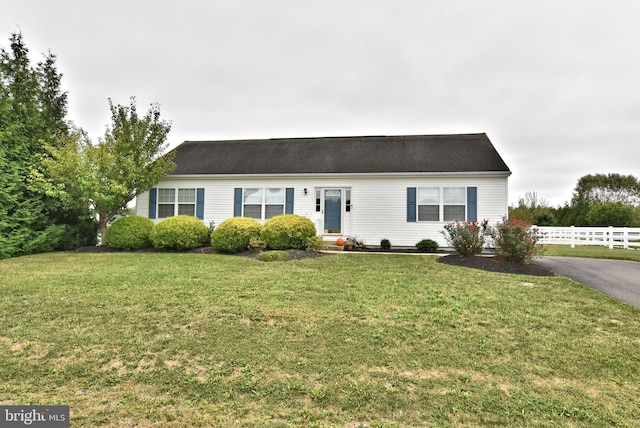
[0,253,640,427]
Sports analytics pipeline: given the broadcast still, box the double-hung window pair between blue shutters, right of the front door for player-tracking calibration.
[414,187,467,222]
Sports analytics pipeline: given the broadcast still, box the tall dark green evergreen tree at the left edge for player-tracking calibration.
[0,33,89,258]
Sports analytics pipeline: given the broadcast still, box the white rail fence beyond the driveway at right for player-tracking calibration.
[534,226,640,250]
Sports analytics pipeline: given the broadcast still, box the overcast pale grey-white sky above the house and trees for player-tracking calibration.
[0,0,640,206]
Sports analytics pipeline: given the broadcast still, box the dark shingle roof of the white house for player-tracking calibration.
[172,134,510,175]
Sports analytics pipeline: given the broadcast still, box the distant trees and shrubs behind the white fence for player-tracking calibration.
[509,173,640,227]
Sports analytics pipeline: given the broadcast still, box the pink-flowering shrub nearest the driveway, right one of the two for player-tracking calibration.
[490,220,544,264]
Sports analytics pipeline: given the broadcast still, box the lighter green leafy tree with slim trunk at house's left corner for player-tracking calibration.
[31,98,175,244]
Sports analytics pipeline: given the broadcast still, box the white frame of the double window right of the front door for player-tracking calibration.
[416,186,468,223]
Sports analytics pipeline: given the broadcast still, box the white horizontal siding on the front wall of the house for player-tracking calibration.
[136,175,508,247]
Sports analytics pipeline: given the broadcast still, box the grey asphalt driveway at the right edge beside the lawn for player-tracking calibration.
[536,257,640,307]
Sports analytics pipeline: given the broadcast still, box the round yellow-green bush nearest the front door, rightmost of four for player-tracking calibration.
[260,214,316,250]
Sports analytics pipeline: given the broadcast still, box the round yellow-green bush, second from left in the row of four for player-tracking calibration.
[150,215,209,250]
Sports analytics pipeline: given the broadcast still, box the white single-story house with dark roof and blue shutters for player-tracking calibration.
[137,134,511,247]
